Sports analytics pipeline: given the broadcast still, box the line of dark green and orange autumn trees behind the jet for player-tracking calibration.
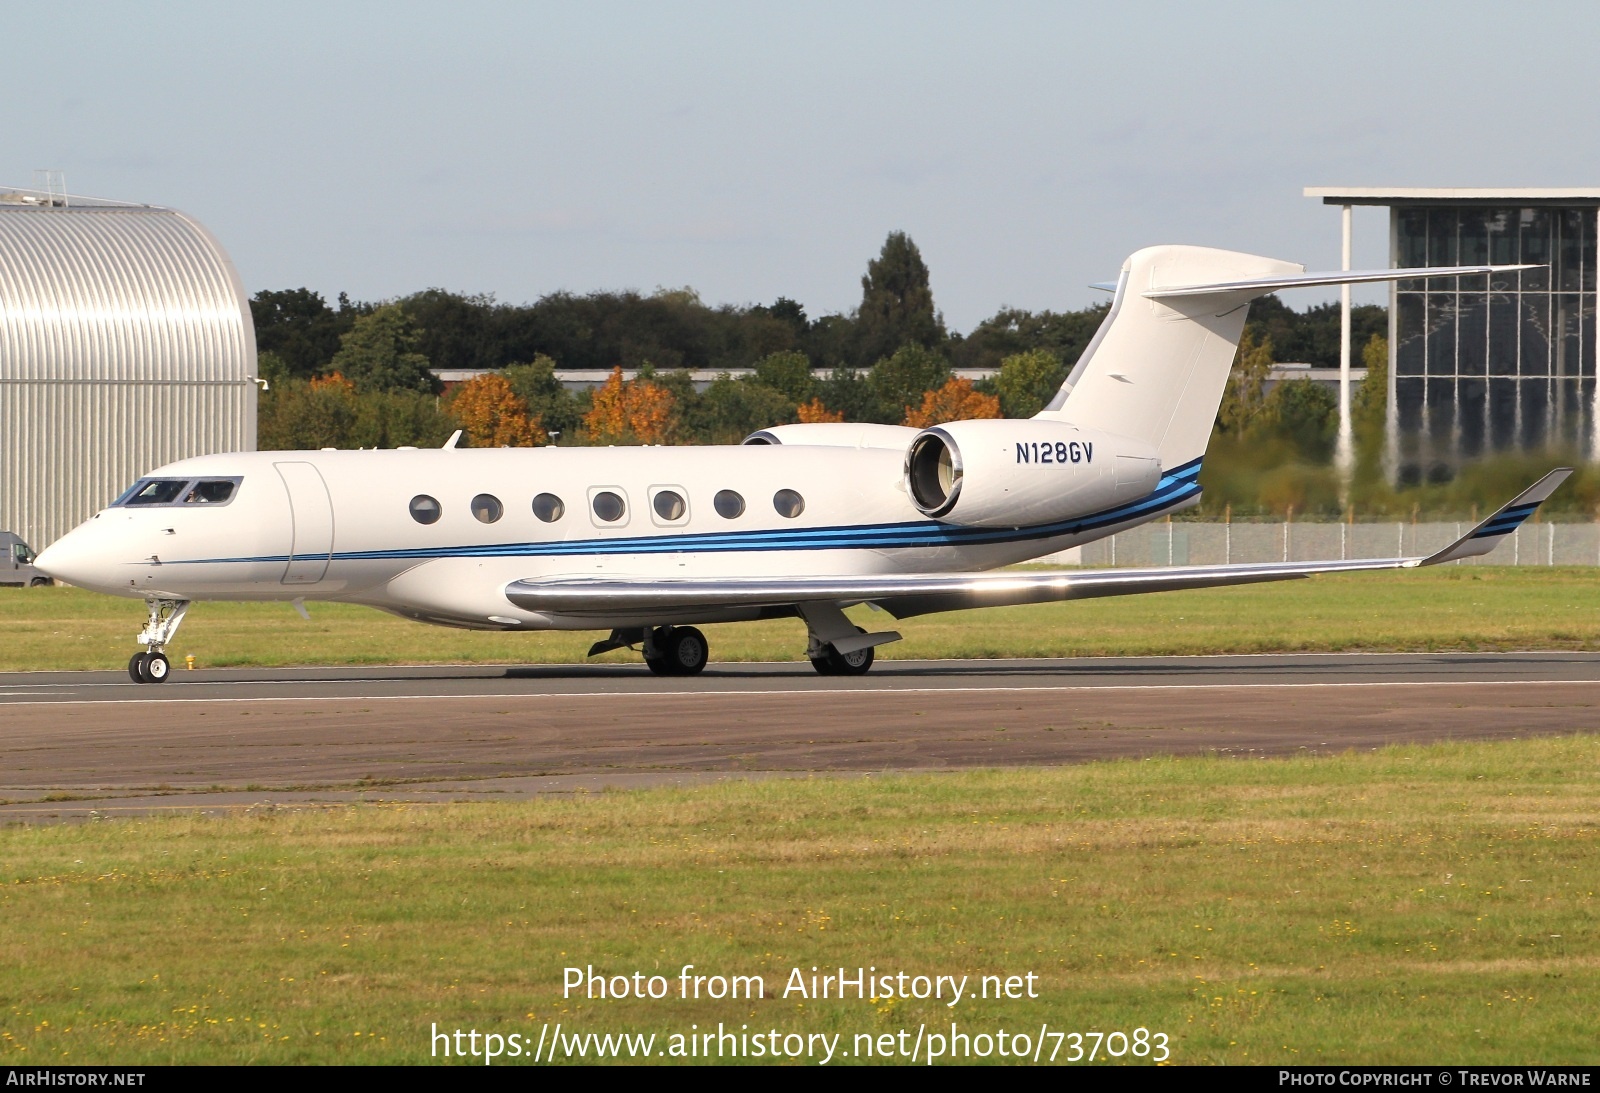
[251,232,1386,450]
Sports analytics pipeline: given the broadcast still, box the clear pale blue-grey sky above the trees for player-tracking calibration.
[0,0,1600,331]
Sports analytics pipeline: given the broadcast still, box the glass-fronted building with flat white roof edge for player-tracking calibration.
[1306,187,1600,485]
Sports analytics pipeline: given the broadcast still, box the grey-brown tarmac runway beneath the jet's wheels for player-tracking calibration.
[0,653,1600,821]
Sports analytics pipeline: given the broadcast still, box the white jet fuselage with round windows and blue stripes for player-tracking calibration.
[37,441,1198,629]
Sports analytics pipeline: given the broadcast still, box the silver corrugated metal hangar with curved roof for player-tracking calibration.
[0,195,256,549]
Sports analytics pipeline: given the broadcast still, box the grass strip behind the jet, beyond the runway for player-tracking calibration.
[0,567,1600,671]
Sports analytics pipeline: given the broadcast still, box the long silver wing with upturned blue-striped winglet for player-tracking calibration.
[506,467,1571,618]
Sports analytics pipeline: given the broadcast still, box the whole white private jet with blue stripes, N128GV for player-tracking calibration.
[38,246,1566,682]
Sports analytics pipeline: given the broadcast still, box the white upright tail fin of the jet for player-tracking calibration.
[1038,246,1306,469]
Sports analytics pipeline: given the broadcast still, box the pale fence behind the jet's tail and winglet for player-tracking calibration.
[1038,520,1600,568]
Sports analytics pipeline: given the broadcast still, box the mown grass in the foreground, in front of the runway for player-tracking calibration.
[0,738,1600,1064]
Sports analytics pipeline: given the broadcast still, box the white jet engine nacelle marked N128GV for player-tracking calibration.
[906,418,1162,528]
